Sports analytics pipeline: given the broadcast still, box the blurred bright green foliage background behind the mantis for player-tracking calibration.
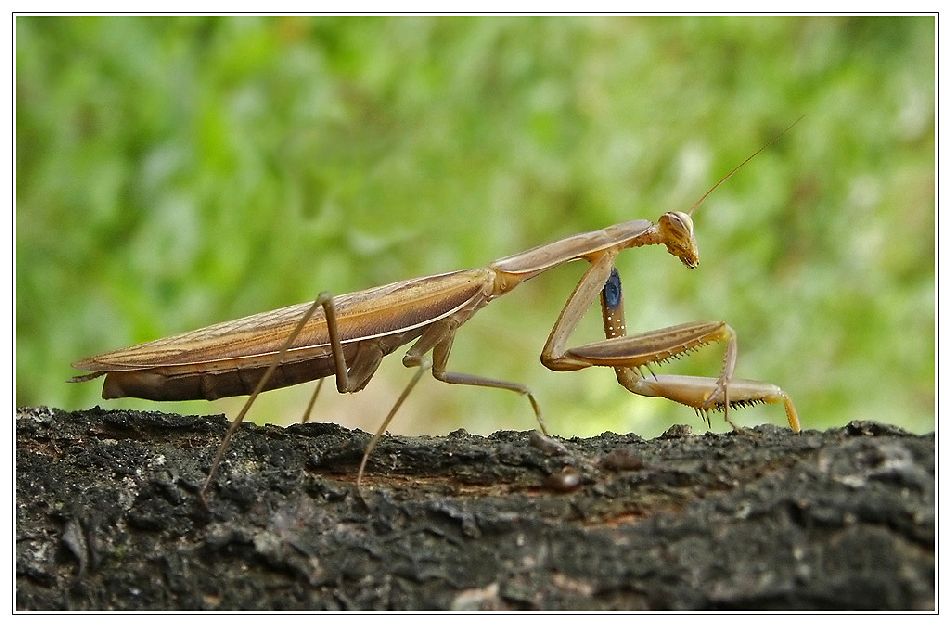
[16,17,935,436]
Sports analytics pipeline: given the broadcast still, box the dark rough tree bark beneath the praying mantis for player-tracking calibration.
[16,408,934,610]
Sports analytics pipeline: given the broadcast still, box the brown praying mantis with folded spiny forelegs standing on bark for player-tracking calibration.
[70,123,801,493]
